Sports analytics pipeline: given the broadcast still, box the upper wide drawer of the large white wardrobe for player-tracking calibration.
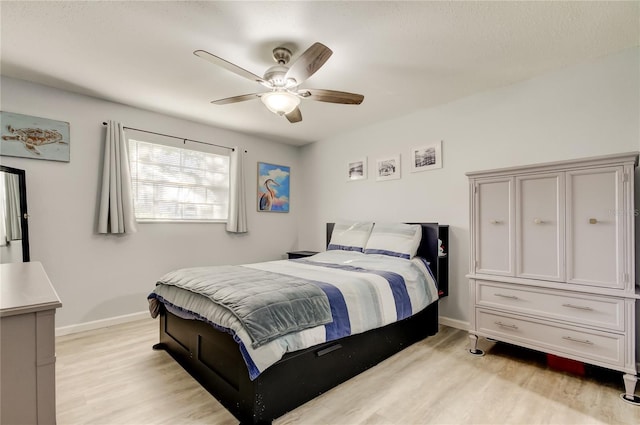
[476,281,625,332]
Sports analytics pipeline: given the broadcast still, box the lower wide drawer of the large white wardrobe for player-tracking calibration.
[476,309,625,366]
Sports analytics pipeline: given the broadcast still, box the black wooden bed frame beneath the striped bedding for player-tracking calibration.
[154,223,438,424]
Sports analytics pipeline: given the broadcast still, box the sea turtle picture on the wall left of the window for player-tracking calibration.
[0,112,71,162]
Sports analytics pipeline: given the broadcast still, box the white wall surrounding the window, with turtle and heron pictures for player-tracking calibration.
[0,77,301,327]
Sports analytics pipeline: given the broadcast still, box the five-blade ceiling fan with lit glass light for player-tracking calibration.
[193,43,364,123]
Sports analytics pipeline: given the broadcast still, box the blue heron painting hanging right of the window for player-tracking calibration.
[258,162,291,212]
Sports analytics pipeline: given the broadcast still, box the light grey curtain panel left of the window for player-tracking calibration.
[98,121,137,234]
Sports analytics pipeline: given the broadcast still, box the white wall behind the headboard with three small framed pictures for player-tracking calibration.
[298,48,640,325]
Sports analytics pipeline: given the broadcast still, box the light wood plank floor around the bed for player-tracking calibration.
[56,319,640,425]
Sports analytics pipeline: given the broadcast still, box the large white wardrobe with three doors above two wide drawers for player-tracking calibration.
[467,152,640,402]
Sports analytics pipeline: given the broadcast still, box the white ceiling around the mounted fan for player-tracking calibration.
[0,1,640,145]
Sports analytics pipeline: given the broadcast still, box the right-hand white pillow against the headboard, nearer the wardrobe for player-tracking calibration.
[364,223,422,260]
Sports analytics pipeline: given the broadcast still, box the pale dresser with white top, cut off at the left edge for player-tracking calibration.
[0,262,62,425]
